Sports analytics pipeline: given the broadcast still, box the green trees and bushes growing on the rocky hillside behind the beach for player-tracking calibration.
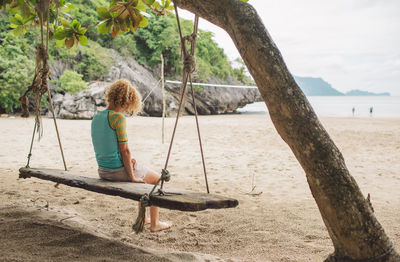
[0,0,249,112]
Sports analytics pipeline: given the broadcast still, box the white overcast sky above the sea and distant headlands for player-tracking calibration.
[181,0,400,96]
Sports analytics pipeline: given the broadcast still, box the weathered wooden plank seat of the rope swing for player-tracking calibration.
[19,167,239,211]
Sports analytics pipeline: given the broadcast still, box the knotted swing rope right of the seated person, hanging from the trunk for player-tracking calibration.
[132,3,210,233]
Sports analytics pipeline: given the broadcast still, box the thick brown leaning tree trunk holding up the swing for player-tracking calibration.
[175,0,400,261]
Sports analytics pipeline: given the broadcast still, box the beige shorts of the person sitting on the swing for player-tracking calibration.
[98,162,151,182]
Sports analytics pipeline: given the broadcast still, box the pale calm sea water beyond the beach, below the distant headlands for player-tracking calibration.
[237,96,400,118]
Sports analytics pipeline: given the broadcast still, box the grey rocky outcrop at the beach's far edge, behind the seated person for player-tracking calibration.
[48,52,261,119]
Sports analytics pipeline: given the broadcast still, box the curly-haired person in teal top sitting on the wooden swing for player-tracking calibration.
[91,80,170,232]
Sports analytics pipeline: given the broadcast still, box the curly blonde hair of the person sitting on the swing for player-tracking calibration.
[105,79,142,115]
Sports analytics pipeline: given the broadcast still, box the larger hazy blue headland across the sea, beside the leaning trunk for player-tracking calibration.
[294,76,345,96]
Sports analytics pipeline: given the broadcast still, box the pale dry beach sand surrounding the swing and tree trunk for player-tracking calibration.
[0,115,400,261]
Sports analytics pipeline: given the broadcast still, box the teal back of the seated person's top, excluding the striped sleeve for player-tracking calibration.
[91,110,124,170]
